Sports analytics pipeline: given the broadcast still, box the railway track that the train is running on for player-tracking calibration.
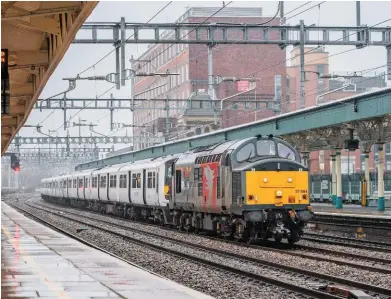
[34,198,391,268]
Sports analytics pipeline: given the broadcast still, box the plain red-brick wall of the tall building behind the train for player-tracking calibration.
[188,18,286,127]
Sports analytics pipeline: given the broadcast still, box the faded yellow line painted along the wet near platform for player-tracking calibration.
[1,220,72,299]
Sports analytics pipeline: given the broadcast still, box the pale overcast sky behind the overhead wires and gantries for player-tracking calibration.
[20,1,391,152]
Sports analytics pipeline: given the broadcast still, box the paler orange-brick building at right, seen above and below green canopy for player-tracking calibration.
[282,47,391,174]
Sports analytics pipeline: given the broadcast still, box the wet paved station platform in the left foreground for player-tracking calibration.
[1,203,212,299]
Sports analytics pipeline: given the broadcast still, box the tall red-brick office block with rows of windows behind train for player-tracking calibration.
[134,7,286,149]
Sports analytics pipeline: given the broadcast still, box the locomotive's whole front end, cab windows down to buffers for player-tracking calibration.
[232,136,313,243]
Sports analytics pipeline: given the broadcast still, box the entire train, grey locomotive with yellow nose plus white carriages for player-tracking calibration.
[41,135,313,243]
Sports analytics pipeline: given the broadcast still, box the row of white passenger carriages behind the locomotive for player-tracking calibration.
[42,154,180,219]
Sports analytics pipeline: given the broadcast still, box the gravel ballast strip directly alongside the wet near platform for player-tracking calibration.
[3,202,309,299]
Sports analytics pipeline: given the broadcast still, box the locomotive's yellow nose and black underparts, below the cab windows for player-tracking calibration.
[243,164,313,243]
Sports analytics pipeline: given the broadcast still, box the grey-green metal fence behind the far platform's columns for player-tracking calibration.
[310,171,391,202]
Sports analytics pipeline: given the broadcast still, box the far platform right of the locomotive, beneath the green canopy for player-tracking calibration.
[311,203,391,220]
